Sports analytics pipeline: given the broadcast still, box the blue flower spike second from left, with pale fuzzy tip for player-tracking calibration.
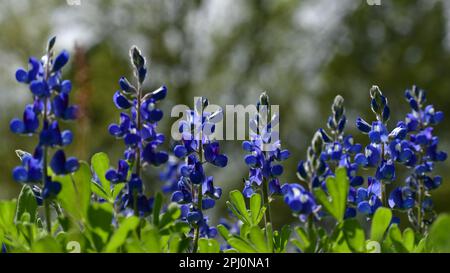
[105,46,168,216]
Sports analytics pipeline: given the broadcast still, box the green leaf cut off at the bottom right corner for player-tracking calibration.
[426,214,450,253]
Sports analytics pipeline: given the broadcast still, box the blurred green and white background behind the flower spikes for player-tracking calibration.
[0,0,450,225]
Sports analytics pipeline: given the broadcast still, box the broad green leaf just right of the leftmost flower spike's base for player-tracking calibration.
[53,162,91,220]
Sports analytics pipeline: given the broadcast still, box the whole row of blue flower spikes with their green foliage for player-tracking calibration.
[0,38,450,253]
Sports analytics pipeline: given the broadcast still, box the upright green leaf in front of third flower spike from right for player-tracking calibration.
[314,168,350,222]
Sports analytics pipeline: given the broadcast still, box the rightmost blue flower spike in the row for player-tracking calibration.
[389,86,447,231]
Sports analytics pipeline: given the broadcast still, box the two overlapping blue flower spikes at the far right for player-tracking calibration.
[355,86,447,227]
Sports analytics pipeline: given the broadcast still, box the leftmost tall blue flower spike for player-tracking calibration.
[10,37,79,230]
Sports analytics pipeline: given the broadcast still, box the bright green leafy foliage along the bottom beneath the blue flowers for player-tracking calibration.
[0,154,450,253]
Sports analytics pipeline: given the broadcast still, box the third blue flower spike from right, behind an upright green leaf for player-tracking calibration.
[284,95,364,221]
